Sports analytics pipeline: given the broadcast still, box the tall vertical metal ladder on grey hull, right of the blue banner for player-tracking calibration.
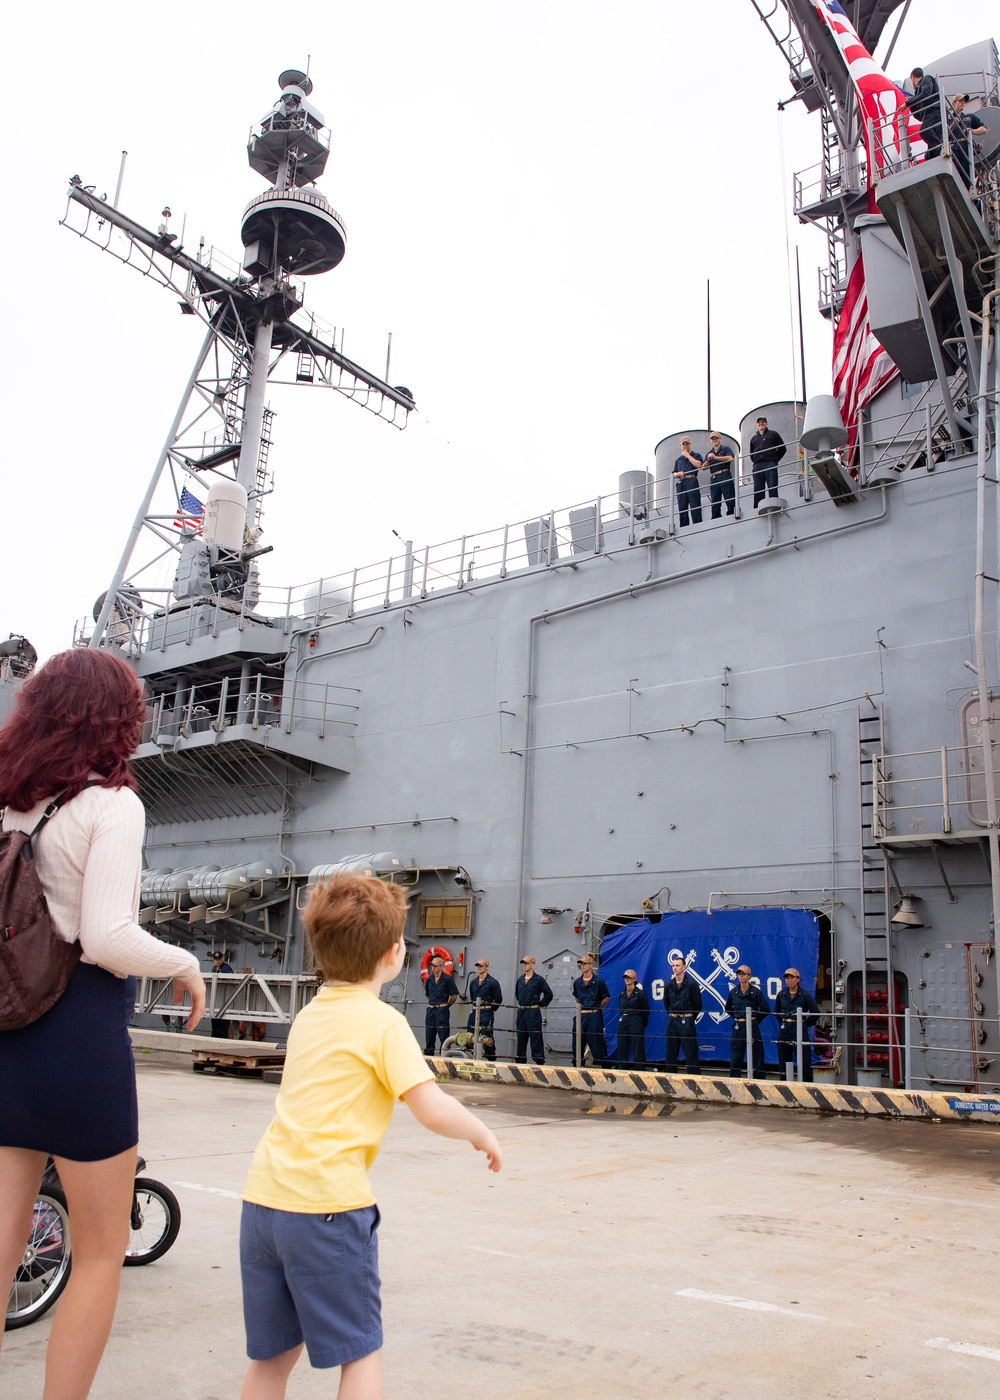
[854,704,899,1079]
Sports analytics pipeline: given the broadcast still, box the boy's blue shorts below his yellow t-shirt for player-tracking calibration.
[239,1201,382,1366]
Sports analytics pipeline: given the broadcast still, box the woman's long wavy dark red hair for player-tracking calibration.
[0,647,146,812]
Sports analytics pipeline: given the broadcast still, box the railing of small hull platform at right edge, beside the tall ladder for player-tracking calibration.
[871,743,987,841]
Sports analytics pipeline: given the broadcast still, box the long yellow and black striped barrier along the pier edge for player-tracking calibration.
[427,1056,1000,1127]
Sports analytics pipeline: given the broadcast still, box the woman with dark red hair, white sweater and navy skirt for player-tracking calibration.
[0,650,204,1400]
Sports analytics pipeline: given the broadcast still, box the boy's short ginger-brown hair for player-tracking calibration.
[303,875,406,981]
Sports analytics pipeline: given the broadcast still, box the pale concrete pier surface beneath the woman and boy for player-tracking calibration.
[0,1065,1000,1400]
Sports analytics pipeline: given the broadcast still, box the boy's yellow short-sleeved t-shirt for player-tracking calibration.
[244,987,434,1214]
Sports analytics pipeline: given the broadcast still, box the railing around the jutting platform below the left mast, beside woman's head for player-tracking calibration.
[143,673,359,745]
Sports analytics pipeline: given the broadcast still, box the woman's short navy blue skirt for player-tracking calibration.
[0,963,139,1162]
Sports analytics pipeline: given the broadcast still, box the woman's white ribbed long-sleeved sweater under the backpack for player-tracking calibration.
[3,787,199,983]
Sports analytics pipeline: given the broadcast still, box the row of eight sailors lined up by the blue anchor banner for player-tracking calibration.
[424,953,819,1084]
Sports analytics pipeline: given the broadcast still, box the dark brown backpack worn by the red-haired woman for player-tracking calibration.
[0,783,81,1030]
